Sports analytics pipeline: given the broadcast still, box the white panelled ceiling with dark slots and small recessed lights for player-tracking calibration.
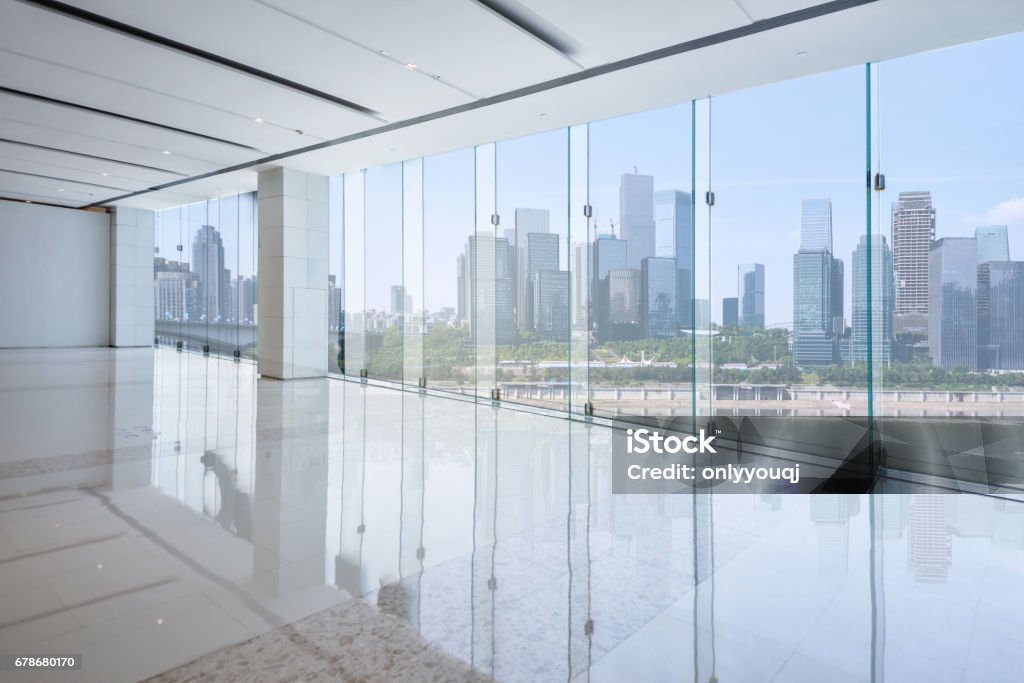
[0,0,1024,208]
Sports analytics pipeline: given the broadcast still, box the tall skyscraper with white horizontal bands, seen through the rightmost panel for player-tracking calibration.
[892,191,935,331]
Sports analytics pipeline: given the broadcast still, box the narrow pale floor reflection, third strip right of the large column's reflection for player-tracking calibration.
[470,403,500,677]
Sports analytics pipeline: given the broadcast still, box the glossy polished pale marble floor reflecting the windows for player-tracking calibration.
[0,349,1024,682]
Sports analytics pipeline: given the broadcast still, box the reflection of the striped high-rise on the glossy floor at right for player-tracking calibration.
[906,484,952,583]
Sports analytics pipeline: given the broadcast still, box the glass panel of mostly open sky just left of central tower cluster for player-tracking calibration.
[423,150,475,393]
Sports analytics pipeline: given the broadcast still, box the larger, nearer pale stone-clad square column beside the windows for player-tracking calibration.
[258,167,328,380]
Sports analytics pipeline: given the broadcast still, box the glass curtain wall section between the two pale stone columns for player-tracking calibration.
[154,193,259,359]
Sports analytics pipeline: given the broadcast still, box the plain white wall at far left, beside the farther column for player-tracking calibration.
[0,201,111,348]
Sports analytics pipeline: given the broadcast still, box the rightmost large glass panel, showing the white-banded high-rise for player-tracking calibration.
[872,34,1024,481]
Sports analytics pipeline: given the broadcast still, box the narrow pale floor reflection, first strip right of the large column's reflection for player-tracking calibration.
[334,382,367,595]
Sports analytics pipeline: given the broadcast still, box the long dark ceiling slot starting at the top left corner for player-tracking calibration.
[20,0,384,121]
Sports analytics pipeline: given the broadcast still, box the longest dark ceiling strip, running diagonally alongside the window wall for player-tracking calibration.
[86,0,878,208]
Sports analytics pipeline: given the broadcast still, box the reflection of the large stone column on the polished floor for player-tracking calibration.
[253,379,328,596]
